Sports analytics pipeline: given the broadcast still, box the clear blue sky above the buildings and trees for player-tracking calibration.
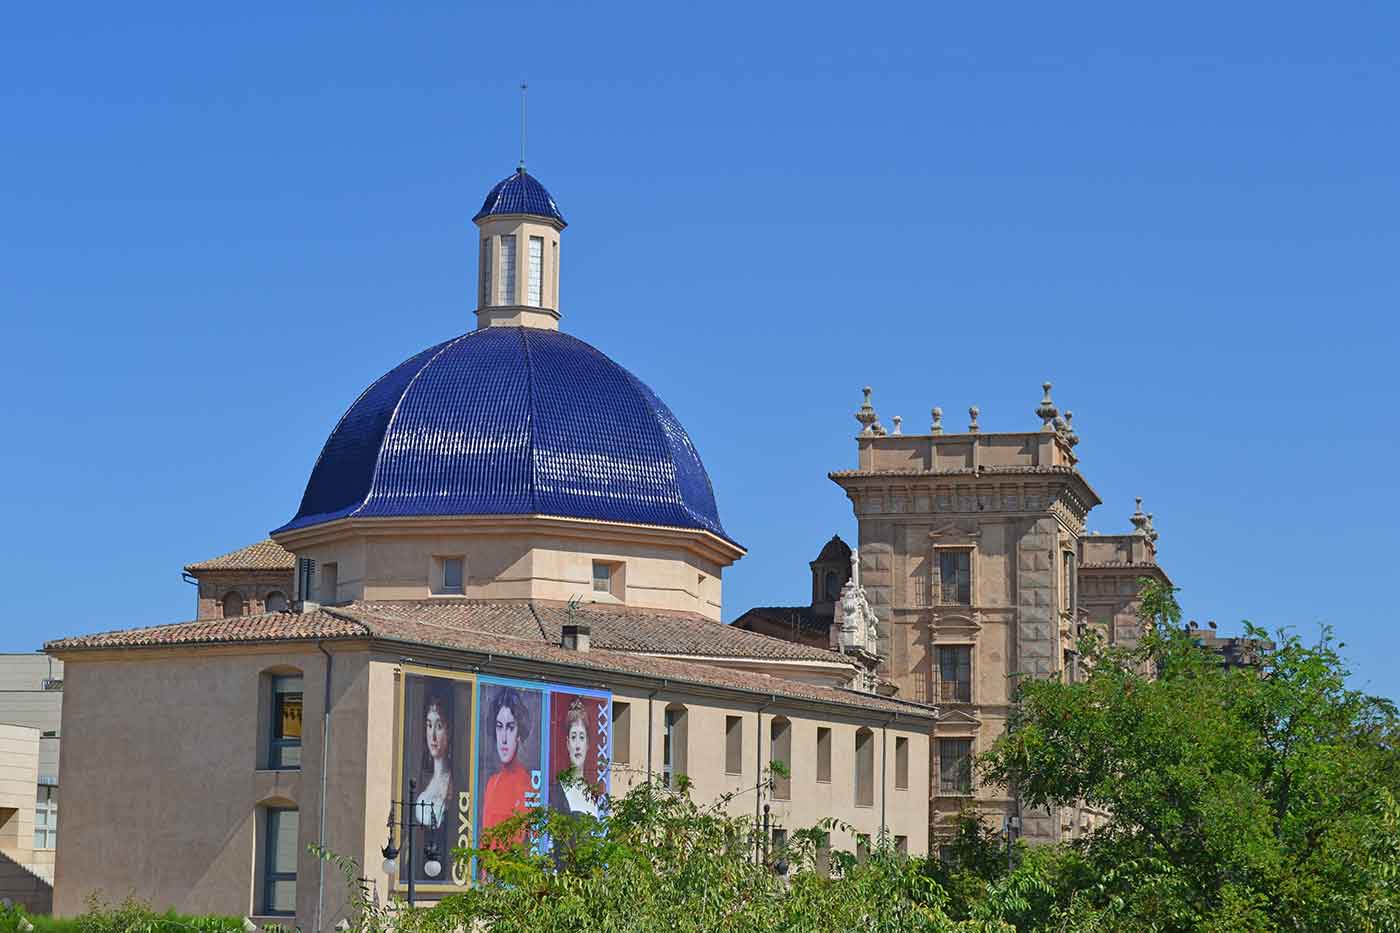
[0,3,1400,698]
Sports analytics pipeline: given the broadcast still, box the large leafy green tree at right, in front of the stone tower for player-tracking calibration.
[980,580,1400,930]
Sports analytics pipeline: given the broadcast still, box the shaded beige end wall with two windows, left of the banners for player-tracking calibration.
[55,646,370,925]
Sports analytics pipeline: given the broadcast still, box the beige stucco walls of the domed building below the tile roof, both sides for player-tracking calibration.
[57,643,928,929]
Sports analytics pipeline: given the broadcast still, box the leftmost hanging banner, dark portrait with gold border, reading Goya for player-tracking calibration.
[393,664,476,894]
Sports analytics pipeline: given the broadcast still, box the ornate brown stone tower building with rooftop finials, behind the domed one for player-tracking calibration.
[735,384,1169,845]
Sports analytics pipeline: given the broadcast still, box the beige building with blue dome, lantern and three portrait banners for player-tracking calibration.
[46,165,935,930]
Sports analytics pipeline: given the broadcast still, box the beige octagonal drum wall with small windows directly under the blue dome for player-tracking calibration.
[290,525,728,619]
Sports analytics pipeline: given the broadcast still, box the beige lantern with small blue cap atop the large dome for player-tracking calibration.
[472,164,567,331]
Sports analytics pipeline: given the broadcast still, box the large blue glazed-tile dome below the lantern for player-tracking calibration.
[277,326,729,541]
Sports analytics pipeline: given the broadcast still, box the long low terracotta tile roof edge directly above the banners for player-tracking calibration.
[43,602,934,719]
